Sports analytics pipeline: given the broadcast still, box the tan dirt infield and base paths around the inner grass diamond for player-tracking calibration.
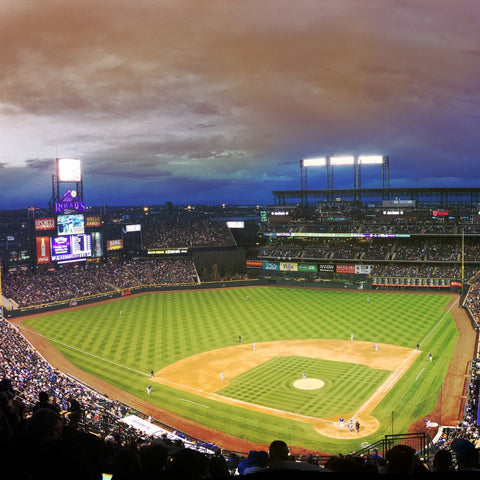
[155,339,420,439]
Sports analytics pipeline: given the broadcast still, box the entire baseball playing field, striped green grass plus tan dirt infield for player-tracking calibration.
[17,286,464,453]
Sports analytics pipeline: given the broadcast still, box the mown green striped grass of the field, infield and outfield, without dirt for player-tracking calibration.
[27,287,458,453]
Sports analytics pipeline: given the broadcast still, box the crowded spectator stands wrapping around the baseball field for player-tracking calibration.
[0,192,480,478]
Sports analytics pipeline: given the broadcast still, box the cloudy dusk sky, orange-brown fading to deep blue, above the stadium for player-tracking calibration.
[0,0,480,209]
